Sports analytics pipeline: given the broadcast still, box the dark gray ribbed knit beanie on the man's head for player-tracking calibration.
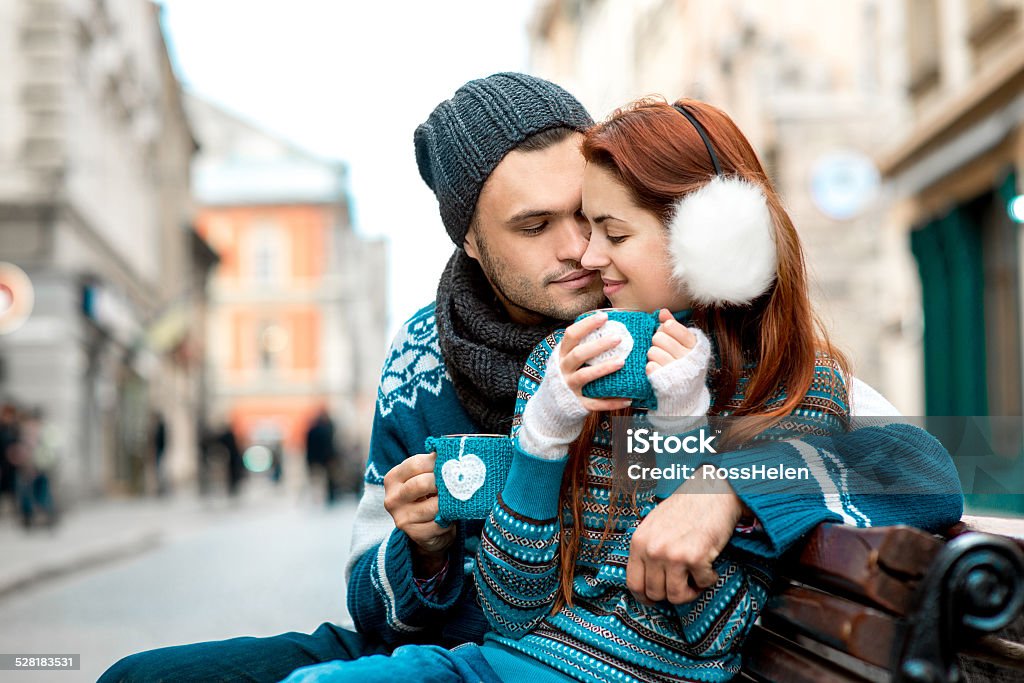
[413,73,594,247]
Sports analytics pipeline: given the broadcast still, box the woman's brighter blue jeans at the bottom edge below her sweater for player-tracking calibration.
[285,644,501,683]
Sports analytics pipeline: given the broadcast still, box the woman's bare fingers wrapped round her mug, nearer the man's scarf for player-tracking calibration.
[558,312,633,412]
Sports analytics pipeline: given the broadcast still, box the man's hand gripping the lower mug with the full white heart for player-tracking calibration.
[384,453,456,579]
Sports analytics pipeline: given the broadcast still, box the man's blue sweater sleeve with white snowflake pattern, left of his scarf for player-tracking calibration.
[346,304,487,646]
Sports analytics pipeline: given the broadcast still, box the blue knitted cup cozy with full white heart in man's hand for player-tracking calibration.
[423,434,513,526]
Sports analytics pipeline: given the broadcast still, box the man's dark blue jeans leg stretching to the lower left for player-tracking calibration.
[98,624,388,683]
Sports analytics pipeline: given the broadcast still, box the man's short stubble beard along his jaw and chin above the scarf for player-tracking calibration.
[476,234,605,321]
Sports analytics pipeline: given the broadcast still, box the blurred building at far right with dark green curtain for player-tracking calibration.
[879,0,1024,514]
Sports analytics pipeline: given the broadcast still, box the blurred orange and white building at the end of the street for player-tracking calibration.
[188,97,387,481]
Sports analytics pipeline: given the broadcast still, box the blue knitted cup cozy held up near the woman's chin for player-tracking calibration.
[577,309,658,409]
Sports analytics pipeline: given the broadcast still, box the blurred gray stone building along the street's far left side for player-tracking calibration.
[0,0,213,499]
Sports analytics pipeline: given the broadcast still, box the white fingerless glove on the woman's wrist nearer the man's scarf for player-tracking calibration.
[516,344,589,460]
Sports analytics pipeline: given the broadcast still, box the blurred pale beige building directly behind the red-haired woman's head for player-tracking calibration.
[530,0,922,405]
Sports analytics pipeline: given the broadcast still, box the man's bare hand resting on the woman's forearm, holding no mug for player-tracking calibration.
[626,474,743,604]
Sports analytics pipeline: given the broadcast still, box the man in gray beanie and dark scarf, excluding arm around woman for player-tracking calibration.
[100,74,604,682]
